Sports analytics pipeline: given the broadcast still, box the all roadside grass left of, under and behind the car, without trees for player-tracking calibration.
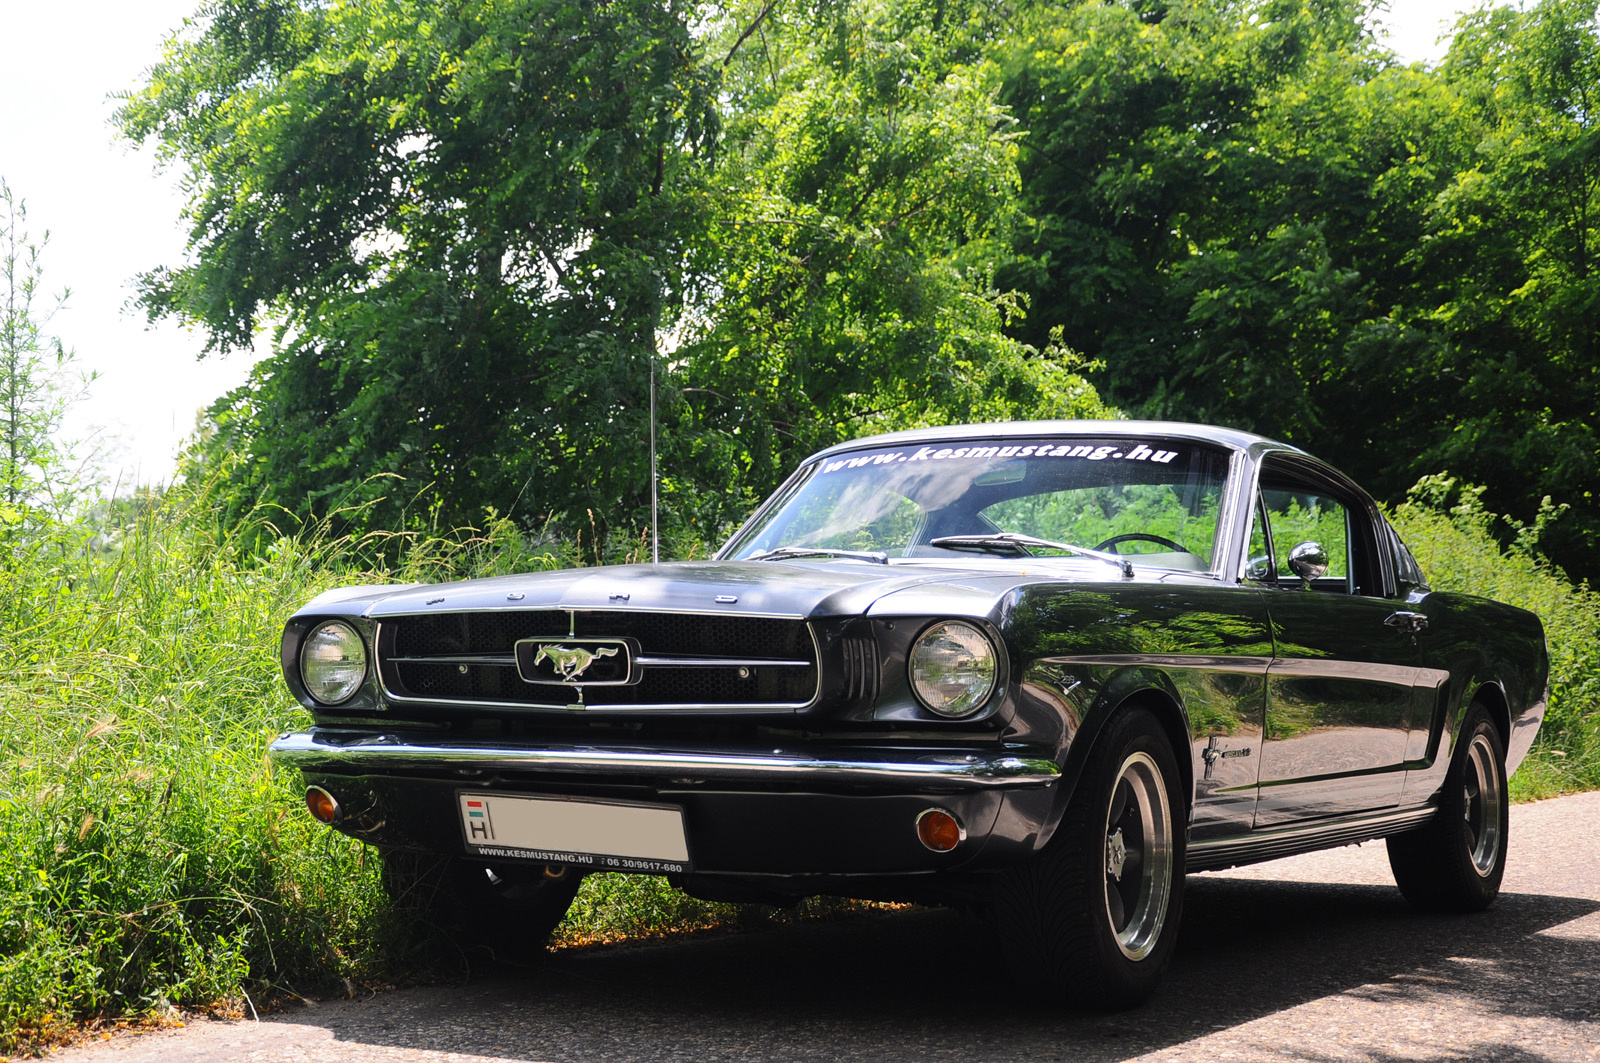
[0,490,1600,1053]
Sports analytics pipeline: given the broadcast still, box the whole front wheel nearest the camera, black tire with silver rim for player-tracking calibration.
[994,709,1187,1010]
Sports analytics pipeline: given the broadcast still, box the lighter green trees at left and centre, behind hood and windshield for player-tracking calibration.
[120,0,1104,547]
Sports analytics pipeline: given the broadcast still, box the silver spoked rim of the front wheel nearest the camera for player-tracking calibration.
[1104,752,1173,961]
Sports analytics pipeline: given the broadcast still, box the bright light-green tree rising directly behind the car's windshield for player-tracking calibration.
[675,0,1107,517]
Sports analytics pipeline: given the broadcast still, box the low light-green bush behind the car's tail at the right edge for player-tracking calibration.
[1392,474,1600,800]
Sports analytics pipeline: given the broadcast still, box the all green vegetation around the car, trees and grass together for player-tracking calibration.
[0,0,1600,1053]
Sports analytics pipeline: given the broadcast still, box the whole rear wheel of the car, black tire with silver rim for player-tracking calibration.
[1387,703,1510,911]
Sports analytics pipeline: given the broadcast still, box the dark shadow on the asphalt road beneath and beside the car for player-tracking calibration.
[281,876,1600,1063]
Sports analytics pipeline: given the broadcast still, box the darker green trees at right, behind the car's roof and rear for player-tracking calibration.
[997,0,1600,578]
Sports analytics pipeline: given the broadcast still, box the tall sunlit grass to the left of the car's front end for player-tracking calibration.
[0,495,379,1047]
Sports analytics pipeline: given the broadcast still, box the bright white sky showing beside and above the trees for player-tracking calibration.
[0,0,1477,487]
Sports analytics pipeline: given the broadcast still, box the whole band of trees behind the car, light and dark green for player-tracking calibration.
[120,0,1600,578]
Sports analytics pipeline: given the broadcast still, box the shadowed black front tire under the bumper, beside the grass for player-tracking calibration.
[382,850,582,961]
